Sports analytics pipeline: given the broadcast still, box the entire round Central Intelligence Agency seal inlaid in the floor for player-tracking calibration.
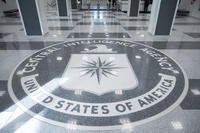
[8,40,188,130]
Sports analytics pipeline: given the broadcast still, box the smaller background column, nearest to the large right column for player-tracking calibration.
[127,0,140,17]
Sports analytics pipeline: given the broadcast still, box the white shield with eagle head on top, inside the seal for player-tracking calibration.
[60,45,138,95]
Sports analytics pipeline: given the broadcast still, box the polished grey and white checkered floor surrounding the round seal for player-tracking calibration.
[0,6,200,133]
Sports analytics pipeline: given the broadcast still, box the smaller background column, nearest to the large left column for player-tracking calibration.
[57,0,71,17]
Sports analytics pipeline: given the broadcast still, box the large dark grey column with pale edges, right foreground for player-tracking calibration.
[149,0,179,35]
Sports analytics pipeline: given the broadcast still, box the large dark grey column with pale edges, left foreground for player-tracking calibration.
[17,0,47,36]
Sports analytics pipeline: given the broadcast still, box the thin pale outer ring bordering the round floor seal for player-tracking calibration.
[8,39,189,131]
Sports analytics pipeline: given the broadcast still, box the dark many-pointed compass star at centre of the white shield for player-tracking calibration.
[73,57,126,84]
